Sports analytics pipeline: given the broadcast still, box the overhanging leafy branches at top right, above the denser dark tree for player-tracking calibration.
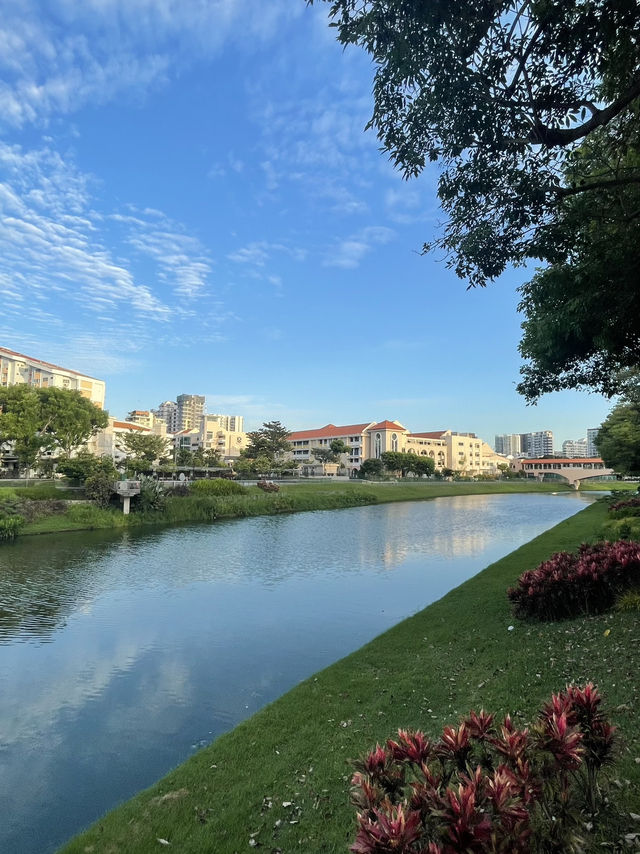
[311,0,640,284]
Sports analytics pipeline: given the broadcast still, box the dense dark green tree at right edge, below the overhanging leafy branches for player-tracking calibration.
[518,127,640,402]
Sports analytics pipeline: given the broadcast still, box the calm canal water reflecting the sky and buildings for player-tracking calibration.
[0,494,592,854]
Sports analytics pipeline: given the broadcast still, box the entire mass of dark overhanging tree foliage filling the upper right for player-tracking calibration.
[309,0,640,401]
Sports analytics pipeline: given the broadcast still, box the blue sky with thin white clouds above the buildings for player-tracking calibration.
[0,0,610,447]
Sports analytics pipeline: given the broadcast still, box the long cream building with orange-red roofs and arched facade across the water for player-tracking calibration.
[289,421,505,476]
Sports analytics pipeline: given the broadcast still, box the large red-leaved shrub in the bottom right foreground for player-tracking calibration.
[350,684,614,854]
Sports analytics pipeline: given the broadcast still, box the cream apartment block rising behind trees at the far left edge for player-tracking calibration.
[0,347,105,409]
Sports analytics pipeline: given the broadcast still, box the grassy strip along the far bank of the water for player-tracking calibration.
[21,480,568,535]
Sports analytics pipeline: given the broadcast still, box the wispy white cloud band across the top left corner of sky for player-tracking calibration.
[0,0,305,127]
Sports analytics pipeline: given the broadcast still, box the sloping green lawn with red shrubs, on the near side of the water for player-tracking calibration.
[62,496,640,854]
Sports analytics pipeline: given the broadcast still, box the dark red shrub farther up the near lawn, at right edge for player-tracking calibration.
[507,541,640,620]
